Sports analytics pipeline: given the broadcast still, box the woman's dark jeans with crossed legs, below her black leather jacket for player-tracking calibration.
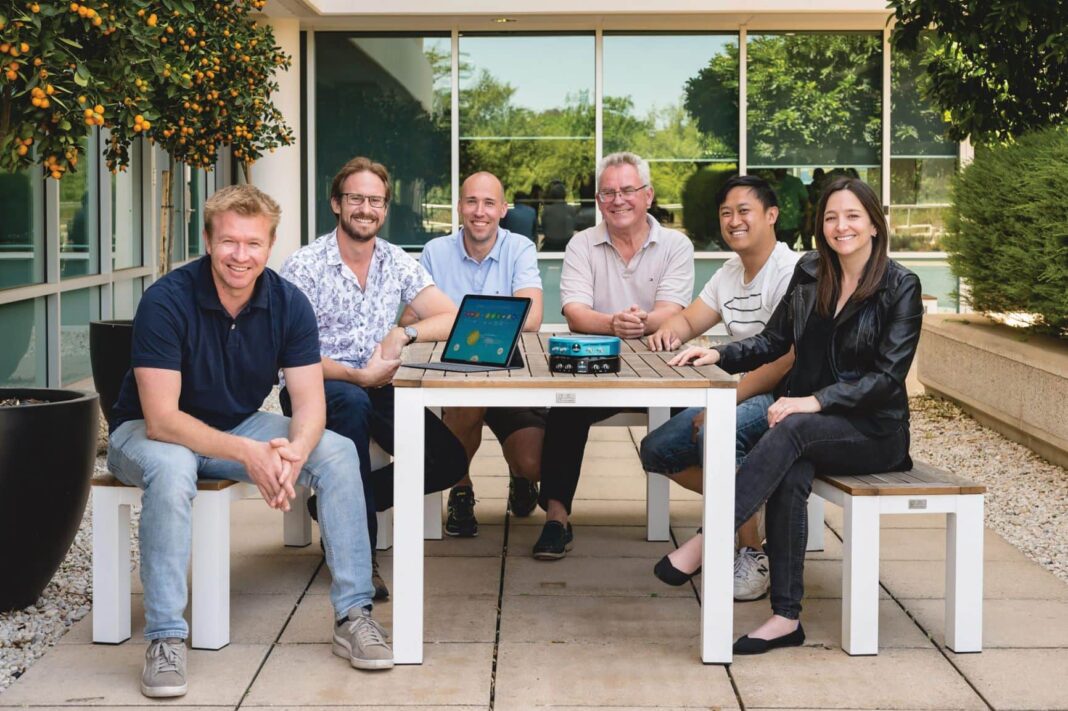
[735,413,912,619]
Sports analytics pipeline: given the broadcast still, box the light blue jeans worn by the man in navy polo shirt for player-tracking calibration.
[108,412,374,639]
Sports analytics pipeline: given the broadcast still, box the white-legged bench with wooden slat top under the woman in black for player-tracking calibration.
[808,461,986,654]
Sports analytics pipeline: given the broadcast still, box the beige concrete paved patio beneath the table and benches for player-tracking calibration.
[0,428,1068,710]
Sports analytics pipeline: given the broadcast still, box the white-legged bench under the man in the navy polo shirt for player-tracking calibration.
[93,475,312,649]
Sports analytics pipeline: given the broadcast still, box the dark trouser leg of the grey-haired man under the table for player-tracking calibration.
[538,408,625,515]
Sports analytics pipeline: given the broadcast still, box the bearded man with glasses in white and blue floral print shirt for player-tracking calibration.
[281,157,468,600]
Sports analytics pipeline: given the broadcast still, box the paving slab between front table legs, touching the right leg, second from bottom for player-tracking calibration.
[501,595,701,648]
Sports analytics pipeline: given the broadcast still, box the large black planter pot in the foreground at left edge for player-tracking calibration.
[0,388,99,611]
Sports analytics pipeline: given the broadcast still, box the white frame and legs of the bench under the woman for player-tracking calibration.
[808,477,984,655]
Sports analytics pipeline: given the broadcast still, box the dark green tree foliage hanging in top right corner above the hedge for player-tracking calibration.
[890,0,1068,143]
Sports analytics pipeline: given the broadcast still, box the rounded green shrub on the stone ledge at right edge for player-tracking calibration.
[945,127,1068,337]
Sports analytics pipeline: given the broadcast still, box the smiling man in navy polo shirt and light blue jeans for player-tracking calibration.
[108,186,393,697]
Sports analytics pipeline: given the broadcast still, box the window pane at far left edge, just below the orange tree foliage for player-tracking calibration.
[0,169,45,289]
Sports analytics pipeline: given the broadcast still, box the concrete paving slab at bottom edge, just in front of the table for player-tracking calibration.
[494,641,738,711]
